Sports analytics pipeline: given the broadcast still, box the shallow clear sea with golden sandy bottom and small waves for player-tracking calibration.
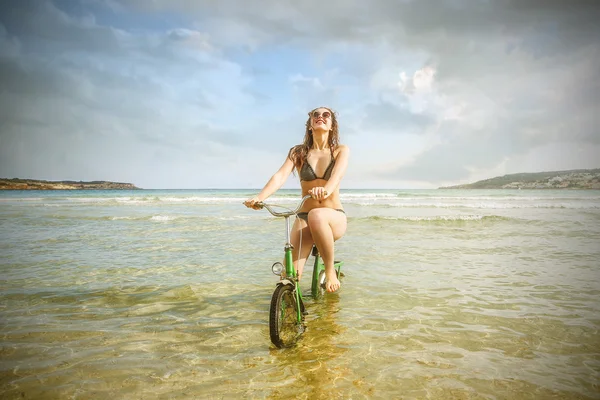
[0,189,600,399]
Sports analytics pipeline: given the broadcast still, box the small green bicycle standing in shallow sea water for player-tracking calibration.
[258,195,344,348]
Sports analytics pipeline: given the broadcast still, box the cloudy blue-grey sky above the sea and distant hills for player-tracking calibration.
[0,0,600,189]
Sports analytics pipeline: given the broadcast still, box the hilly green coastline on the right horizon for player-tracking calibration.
[439,168,600,189]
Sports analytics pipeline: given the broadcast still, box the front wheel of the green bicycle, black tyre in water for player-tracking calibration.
[269,285,304,348]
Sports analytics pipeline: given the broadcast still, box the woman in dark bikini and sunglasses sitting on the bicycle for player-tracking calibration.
[244,107,350,292]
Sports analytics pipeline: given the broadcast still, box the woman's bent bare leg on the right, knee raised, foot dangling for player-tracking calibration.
[308,208,347,292]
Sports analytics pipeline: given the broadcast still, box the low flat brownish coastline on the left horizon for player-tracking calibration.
[0,178,140,190]
